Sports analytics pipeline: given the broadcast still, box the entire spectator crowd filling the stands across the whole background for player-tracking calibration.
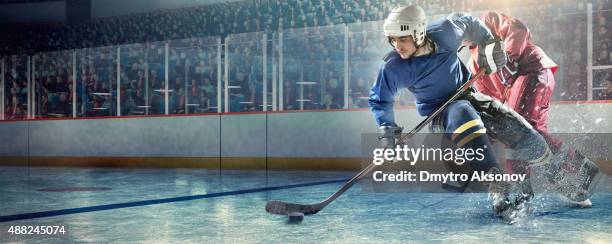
[0,0,612,117]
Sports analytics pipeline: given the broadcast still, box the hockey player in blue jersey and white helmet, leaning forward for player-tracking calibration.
[369,6,550,223]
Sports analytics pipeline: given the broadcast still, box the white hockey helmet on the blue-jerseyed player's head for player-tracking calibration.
[383,5,427,46]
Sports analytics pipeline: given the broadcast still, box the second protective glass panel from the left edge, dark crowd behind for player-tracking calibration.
[33,51,74,118]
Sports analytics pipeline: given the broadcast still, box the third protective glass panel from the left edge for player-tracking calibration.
[76,47,117,117]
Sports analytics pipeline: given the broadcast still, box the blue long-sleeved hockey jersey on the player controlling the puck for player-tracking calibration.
[369,14,492,125]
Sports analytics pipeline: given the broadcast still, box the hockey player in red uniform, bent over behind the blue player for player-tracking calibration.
[468,12,599,207]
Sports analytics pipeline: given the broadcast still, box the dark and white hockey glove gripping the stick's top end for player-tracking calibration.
[478,38,507,75]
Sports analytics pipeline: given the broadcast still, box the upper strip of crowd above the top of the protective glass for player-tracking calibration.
[0,0,610,54]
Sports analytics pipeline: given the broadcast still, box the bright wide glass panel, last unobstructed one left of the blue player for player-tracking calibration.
[281,25,345,110]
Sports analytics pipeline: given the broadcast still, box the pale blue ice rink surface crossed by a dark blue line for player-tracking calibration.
[0,167,612,243]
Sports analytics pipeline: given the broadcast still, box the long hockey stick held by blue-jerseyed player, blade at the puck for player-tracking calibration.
[266,68,485,215]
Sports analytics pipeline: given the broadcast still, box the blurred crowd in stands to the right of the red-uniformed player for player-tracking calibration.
[521,0,612,100]
